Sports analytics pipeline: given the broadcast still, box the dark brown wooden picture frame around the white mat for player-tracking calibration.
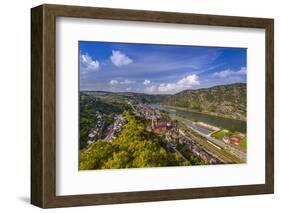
[31,5,274,208]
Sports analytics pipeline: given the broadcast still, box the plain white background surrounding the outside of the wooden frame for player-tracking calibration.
[0,0,281,213]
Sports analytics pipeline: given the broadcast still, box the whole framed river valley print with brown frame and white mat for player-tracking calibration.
[31,5,274,208]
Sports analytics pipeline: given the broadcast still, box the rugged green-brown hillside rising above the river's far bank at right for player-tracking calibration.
[163,83,247,120]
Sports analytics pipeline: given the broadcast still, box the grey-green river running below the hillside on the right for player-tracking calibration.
[149,104,247,133]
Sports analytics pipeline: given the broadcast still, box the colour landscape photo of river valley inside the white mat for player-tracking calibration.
[77,41,247,170]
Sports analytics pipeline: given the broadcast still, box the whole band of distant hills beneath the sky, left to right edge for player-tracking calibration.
[80,83,247,121]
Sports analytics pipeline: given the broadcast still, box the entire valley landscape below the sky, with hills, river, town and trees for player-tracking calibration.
[79,84,247,170]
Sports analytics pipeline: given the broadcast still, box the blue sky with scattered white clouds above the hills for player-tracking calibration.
[79,41,247,94]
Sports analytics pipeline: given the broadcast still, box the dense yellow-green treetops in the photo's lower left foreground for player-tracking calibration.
[80,112,184,170]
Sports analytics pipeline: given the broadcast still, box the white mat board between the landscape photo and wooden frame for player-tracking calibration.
[56,18,265,195]
